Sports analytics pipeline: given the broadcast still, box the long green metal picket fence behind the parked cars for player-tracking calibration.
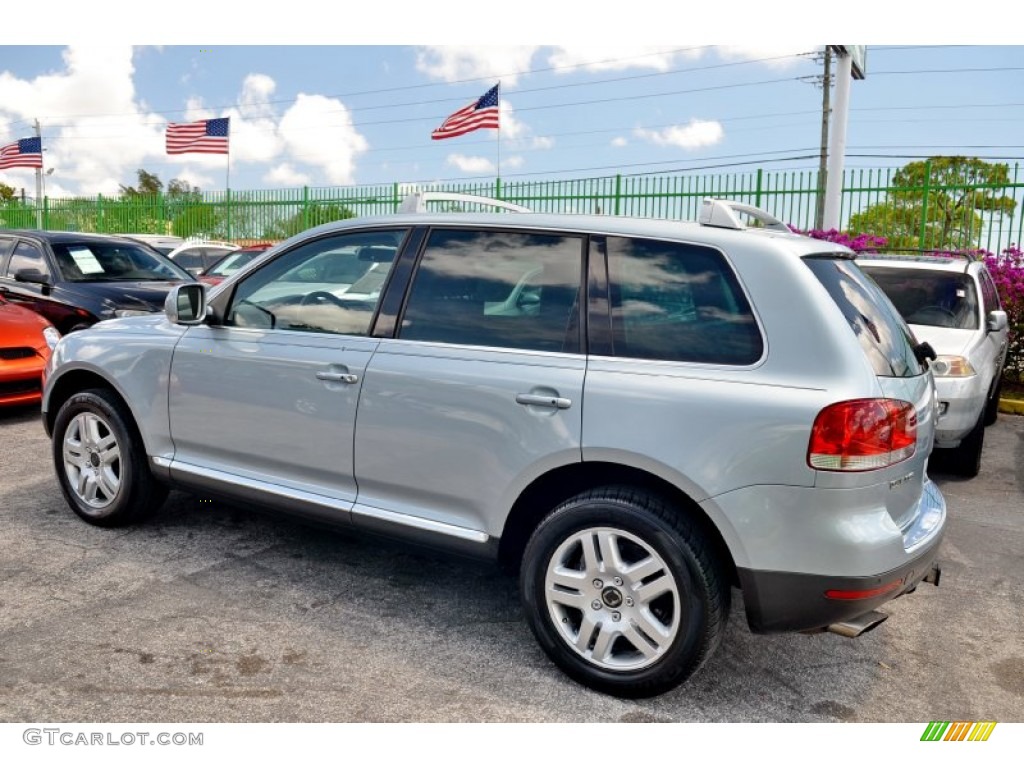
[6,165,1024,251]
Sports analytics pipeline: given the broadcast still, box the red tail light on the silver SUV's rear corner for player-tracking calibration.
[807,398,918,472]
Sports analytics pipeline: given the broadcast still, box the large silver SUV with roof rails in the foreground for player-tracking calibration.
[43,200,946,696]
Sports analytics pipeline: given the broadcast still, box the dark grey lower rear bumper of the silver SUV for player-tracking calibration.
[738,532,942,633]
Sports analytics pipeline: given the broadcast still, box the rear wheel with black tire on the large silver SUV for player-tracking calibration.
[520,486,730,698]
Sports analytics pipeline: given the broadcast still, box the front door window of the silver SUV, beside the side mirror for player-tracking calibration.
[224,229,407,336]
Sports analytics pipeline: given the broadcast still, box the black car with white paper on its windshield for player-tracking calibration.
[0,229,195,334]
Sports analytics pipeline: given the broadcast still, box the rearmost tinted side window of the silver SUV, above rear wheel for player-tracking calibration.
[597,238,764,366]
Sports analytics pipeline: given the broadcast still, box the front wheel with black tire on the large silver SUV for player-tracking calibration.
[52,389,167,527]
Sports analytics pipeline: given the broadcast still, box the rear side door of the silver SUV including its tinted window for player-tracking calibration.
[353,228,586,542]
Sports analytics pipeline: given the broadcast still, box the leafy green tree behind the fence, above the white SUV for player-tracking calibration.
[850,157,1017,249]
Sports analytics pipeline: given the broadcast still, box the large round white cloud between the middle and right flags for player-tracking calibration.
[279,93,370,184]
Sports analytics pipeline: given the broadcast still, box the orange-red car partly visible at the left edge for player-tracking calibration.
[0,295,60,407]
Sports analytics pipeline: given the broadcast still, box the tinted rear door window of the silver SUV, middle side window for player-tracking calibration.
[399,229,583,352]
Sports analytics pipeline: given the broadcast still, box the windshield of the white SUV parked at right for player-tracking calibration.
[862,265,978,329]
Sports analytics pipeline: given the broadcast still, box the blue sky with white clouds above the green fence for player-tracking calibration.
[0,3,1024,197]
